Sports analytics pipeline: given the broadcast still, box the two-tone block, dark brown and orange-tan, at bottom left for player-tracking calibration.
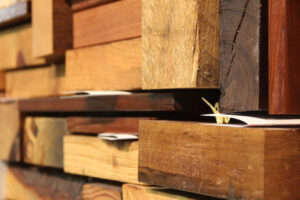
[6,166,86,200]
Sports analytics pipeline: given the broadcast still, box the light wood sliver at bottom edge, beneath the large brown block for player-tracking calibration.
[122,184,217,200]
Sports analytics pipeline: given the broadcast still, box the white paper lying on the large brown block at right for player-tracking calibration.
[201,114,300,127]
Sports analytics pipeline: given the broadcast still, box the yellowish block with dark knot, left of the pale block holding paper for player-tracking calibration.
[23,117,68,168]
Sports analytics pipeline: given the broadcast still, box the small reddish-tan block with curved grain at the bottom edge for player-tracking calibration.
[82,183,122,200]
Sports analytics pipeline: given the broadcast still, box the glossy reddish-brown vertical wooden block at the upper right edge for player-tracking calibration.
[269,0,300,114]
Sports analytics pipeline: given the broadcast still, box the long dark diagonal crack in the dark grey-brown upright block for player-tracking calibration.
[224,0,250,81]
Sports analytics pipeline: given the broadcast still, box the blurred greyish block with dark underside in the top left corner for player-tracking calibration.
[0,1,31,29]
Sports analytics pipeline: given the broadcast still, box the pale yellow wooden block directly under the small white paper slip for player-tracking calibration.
[64,135,138,183]
